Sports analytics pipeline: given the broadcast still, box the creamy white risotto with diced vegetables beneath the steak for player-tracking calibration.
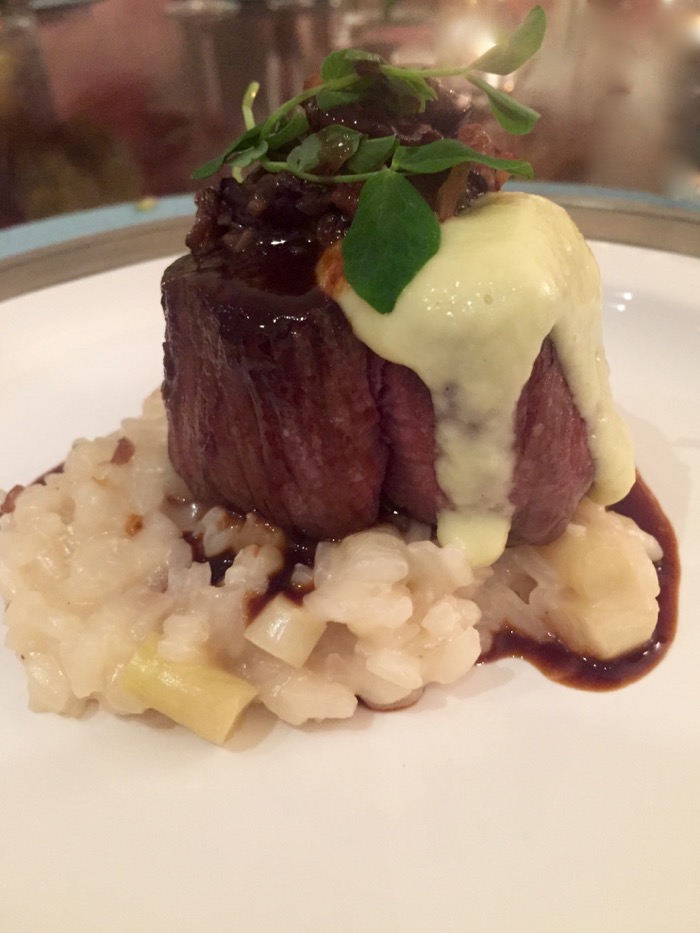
[0,392,660,742]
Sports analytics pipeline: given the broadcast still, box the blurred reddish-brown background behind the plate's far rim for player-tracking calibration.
[0,0,700,227]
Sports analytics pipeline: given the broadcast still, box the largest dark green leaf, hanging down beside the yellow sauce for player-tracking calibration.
[343,169,440,314]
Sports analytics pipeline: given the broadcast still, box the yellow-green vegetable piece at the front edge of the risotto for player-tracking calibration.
[121,636,258,745]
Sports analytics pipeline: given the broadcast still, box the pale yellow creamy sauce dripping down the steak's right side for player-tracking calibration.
[334,192,635,566]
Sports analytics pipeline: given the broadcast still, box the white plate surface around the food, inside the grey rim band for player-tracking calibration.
[0,243,700,933]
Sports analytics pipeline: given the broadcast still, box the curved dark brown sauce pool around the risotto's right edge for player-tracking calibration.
[480,474,680,690]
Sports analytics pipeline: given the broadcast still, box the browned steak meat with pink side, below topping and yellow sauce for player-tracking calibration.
[163,256,593,544]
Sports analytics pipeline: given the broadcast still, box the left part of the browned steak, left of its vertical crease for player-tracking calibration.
[163,256,387,539]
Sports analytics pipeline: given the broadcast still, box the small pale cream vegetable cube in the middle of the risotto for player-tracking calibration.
[245,593,326,667]
